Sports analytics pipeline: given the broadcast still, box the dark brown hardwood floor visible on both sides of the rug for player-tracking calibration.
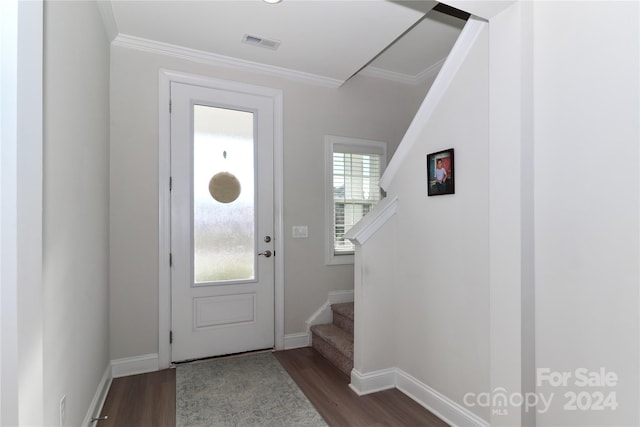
[100,348,447,427]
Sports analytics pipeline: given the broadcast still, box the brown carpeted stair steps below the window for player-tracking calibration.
[311,302,353,376]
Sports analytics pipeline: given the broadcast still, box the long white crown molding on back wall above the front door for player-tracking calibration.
[112,34,344,88]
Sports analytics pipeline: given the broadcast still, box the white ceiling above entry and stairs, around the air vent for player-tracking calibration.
[103,0,464,86]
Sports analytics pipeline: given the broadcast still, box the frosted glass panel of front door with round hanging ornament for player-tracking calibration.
[193,105,256,284]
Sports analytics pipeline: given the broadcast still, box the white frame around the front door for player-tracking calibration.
[158,69,284,369]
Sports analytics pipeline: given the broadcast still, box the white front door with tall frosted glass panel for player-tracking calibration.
[171,82,275,362]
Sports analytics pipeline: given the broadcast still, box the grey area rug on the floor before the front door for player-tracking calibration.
[176,352,327,427]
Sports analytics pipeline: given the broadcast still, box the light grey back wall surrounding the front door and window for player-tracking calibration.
[110,46,426,359]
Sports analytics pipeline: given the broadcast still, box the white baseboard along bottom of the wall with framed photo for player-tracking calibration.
[349,368,489,427]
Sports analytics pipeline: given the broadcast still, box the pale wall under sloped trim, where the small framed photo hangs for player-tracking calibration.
[388,23,489,418]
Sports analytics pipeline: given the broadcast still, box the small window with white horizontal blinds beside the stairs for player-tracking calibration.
[327,137,386,264]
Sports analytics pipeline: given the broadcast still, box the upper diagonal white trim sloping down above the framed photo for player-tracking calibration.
[380,17,488,190]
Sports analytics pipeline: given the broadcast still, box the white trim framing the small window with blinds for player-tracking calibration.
[324,135,387,265]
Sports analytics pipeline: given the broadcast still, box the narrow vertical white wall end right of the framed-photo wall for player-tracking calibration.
[488,2,535,426]
